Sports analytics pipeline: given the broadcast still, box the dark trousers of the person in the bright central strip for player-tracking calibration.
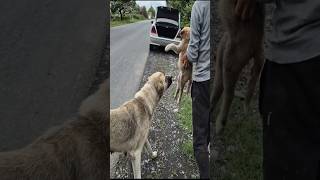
[191,80,210,179]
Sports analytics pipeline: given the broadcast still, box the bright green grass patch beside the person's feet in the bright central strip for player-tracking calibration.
[178,90,194,161]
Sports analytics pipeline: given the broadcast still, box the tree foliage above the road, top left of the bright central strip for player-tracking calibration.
[110,0,136,21]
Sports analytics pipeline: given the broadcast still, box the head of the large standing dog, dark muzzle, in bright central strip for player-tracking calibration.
[148,72,172,95]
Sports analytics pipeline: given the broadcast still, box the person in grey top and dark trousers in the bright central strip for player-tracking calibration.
[182,1,210,179]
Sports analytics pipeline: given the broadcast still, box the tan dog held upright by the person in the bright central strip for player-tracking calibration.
[165,27,192,103]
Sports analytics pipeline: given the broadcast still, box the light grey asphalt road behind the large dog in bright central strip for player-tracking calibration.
[110,21,151,177]
